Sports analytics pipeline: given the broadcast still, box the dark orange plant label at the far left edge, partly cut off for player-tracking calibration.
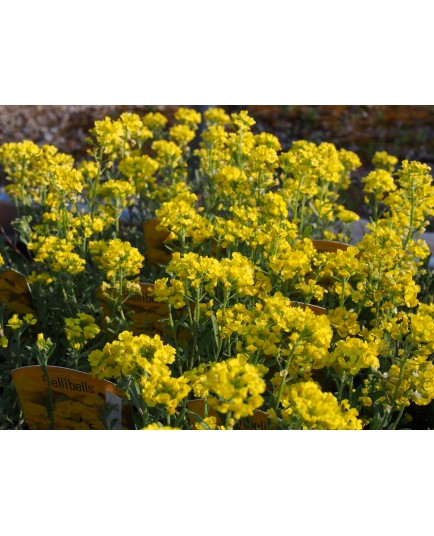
[0,268,36,314]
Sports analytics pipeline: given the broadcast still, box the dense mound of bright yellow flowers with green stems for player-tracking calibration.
[0,108,434,430]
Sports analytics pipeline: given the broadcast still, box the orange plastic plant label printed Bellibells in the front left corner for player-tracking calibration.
[11,365,132,430]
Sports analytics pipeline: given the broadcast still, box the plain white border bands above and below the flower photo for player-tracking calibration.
[0,0,433,536]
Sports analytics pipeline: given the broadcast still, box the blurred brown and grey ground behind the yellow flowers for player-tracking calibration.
[0,104,434,216]
